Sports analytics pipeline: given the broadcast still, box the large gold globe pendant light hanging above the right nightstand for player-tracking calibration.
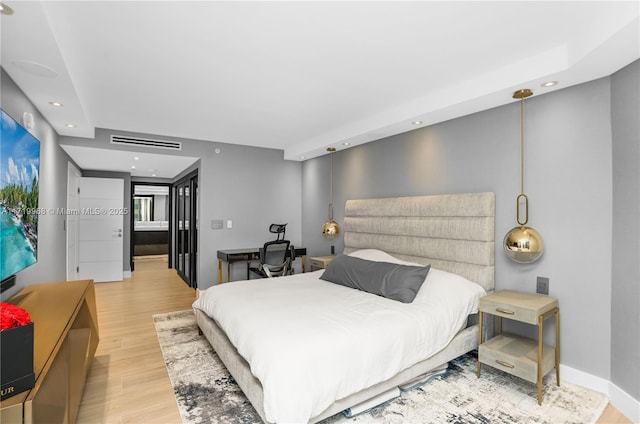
[503,88,544,263]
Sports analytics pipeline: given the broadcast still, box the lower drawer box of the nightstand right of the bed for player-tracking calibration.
[478,333,555,383]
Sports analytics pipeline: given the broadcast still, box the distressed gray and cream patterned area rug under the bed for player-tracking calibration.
[153,310,608,424]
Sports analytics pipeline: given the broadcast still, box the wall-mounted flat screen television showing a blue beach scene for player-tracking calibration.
[0,109,40,291]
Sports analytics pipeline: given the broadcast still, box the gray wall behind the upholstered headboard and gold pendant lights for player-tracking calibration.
[302,78,620,379]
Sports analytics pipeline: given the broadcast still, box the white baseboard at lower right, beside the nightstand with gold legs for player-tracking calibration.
[560,364,640,423]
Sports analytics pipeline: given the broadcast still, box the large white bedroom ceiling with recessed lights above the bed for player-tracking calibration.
[1,0,640,174]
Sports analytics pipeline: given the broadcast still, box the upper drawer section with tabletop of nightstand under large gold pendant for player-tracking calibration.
[479,291,558,325]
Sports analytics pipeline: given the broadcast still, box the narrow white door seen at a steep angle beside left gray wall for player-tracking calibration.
[66,162,82,281]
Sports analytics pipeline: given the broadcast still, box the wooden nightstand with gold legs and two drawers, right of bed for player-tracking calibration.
[477,290,560,405]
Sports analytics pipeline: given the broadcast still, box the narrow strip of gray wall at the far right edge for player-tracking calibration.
[611,61,640,399]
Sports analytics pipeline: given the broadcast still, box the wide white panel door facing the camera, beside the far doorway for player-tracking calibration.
[79,177,128,282]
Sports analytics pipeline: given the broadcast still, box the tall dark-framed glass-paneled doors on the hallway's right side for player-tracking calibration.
[172,171,199,288]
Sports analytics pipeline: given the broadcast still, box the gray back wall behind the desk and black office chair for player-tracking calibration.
[60,129,302,289]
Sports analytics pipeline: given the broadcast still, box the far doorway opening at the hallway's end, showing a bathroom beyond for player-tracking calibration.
[131,181,171,271]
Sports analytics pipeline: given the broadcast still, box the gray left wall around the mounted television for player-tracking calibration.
[0,69,70,299]
